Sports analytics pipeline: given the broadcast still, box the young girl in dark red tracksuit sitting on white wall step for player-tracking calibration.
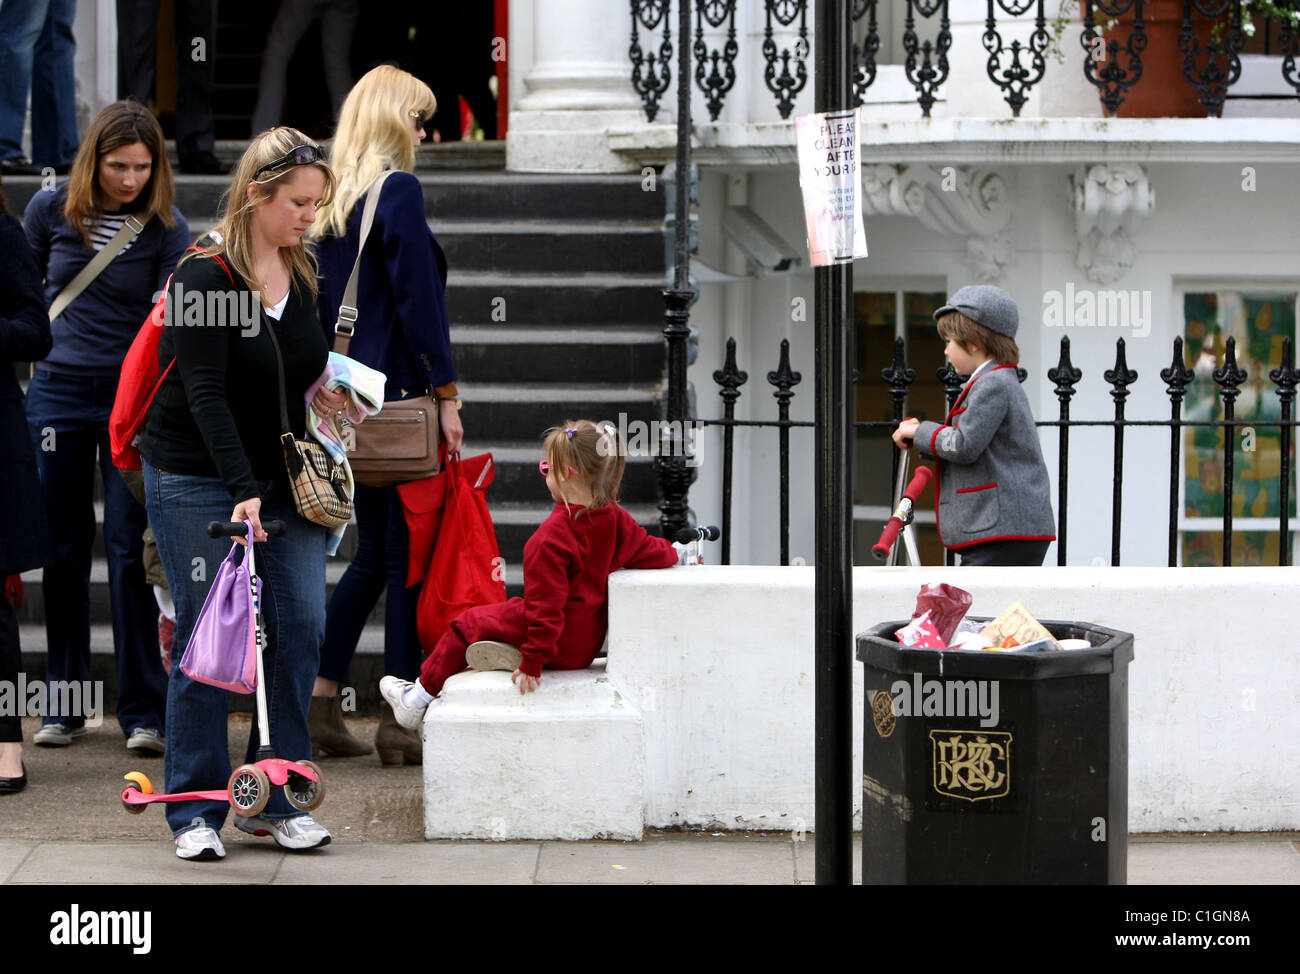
[380,420,677,728]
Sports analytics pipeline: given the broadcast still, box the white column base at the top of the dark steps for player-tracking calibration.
[506,0,650,172]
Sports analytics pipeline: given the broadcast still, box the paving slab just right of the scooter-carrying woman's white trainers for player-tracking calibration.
[274,843,541,886]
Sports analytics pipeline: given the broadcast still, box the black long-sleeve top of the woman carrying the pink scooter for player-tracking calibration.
[140,256,329,503]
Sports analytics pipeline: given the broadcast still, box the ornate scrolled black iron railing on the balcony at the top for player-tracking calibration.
[628,0,1300,121]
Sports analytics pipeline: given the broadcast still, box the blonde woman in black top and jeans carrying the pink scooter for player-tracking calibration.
[140,127,343,860]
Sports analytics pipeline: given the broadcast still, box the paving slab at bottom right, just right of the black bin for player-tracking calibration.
[1128,835,1300,886]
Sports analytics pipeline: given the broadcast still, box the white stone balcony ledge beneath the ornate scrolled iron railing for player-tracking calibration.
[606,118,1300,168]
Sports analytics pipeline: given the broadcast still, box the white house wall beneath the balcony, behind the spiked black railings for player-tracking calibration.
[690,156,1300,566]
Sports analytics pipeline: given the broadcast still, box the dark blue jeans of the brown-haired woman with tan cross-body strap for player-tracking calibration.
[27,368,166,737]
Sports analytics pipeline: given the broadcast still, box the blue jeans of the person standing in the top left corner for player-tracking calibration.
[0,0,77,165]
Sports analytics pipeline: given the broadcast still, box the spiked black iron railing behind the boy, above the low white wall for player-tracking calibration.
[689,337,1300,566]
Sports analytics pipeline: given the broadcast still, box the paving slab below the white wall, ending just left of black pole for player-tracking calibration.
[537,835,794,886]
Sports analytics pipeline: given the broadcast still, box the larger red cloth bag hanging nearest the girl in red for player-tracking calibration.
[413,454,506,655]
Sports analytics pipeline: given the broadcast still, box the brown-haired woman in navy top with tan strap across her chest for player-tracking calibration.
[22,101,190,756]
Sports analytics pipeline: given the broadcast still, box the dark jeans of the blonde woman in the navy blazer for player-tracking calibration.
[320,484,421,683]
